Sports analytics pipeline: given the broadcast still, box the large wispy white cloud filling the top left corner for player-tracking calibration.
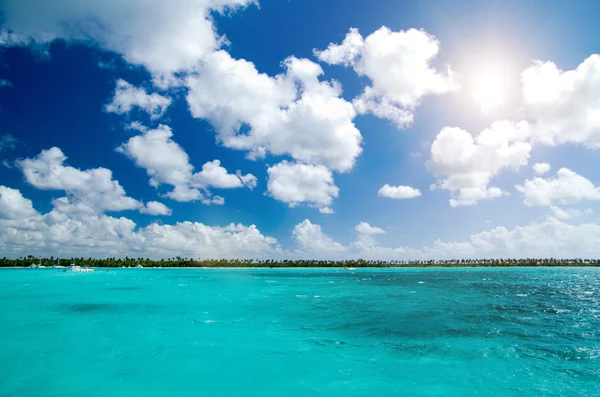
[0,0,254,83]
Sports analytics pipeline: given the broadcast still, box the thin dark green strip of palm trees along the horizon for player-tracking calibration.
[0,255,600,268]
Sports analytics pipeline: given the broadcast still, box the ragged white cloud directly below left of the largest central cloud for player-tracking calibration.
[117,125,256,204]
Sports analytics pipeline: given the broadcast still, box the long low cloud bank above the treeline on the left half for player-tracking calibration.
[0,211,279,259]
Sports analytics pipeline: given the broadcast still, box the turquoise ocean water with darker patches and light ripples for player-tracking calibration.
[0,268,600,397]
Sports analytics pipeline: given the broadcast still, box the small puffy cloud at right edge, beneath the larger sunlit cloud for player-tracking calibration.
[515,168,600,206]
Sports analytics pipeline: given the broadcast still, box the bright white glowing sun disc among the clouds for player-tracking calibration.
[471,69,506,113]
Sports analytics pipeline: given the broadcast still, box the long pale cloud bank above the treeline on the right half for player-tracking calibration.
[294,217,600,260]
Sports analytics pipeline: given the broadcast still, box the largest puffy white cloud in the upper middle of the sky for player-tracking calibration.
[186,51,362,172]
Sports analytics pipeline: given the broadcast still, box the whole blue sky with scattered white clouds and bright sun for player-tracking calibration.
[0,0,600,260]
